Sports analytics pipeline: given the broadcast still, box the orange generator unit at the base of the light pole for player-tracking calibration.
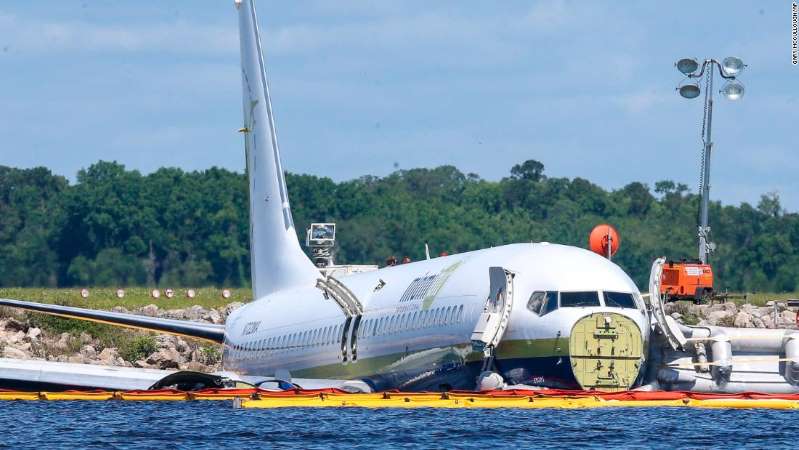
[660,261,713,303]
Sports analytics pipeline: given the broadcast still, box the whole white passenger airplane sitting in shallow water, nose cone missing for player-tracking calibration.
[0,0,650,391]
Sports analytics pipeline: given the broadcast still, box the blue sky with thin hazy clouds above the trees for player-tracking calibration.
[0,0,799,212]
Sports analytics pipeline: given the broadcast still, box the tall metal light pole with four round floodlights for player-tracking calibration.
[674,56,746,264]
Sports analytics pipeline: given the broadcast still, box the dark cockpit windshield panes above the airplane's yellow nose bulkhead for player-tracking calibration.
[527,291,638,316]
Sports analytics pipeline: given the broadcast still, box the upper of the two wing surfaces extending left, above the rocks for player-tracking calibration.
[0,298,225,344]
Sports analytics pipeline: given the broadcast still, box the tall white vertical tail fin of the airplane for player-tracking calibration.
[235,0,320,299]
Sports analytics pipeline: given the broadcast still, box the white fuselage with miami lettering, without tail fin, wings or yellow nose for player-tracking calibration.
[223,243,649,388]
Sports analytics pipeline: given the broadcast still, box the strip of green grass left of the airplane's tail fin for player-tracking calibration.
[0,288,252,309]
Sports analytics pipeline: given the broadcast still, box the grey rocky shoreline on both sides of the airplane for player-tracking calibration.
[0,302,796,372]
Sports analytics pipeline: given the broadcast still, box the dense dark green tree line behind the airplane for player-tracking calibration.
[0,160,799,292]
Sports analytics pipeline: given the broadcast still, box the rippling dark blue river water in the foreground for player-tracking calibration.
[0,401,799,449]
